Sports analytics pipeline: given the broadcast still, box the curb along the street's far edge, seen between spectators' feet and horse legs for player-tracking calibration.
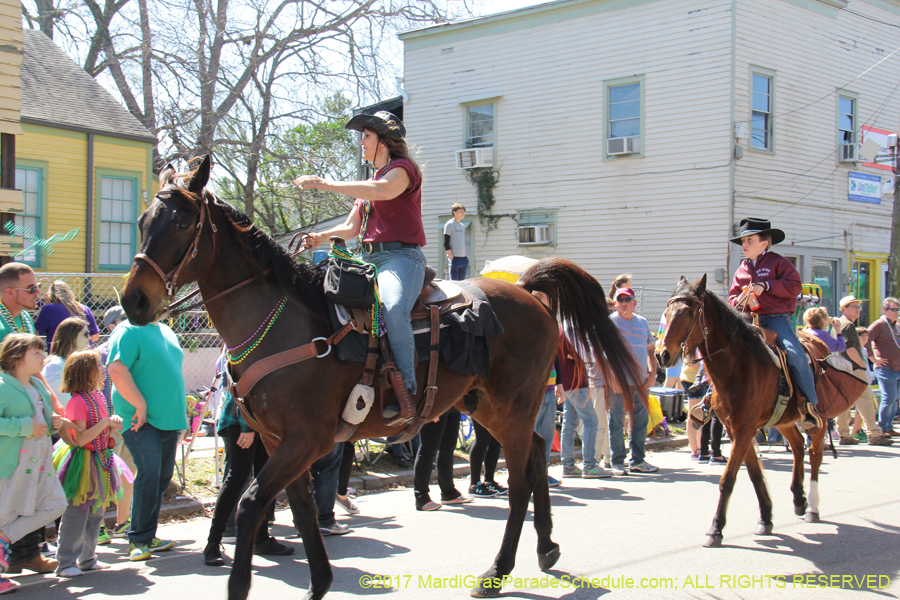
[149,435,688,525]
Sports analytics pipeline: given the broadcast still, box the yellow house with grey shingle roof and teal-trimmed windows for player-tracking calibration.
[15,29,156,273]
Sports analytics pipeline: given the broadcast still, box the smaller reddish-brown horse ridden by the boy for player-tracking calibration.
[656,275,833,548]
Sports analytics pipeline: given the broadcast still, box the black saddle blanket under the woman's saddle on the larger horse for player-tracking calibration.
[328,281,503,377]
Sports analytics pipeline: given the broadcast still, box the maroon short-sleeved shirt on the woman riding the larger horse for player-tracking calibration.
[354,158,425,246]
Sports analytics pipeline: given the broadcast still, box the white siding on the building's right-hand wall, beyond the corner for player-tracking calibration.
[735,0,900,252]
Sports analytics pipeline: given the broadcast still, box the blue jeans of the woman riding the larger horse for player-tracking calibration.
[363,248,425,394]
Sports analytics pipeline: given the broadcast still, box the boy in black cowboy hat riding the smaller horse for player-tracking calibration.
[728,217,822,429]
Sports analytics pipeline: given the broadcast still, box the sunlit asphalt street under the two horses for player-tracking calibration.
[17,438,900,600]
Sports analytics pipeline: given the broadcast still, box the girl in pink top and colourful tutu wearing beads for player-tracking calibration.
[53,350,133,577]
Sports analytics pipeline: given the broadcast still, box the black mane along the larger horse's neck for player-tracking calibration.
[204,190,327,319]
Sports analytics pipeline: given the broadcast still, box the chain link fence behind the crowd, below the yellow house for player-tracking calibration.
[31,273,222,392]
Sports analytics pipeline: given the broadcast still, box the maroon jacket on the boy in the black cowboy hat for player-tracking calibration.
[728,252,802,315]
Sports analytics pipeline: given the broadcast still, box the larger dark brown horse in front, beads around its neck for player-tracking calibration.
[122,157,638,600]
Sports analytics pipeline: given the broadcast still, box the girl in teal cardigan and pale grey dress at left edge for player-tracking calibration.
[0,333,72,594]
